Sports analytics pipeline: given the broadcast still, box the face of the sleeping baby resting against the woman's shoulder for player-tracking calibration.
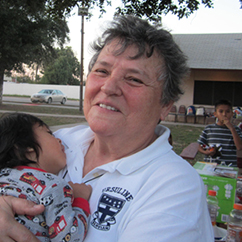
[30,124,66,174]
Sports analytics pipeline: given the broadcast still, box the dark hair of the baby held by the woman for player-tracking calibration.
[0,113,48,169]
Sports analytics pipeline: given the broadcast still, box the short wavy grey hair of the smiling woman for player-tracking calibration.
[89,15,189,104]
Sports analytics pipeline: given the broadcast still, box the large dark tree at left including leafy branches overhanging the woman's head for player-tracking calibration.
[3,0,242,105]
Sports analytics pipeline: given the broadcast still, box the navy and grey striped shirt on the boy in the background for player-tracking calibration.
[197,124,242,166]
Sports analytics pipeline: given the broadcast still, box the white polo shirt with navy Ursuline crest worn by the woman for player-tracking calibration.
[55,125,214,242]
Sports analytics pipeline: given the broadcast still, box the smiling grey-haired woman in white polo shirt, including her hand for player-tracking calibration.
[0,16,214,242]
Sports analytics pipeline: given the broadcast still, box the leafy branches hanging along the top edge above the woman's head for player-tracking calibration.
[46,0,215,21]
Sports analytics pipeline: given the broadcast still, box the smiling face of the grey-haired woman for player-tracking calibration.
[84,40,173,139]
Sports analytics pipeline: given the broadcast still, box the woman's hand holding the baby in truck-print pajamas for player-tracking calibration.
[0,196,44,242]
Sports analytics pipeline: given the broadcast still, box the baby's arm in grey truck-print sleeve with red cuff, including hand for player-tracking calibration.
[41,178,91,242]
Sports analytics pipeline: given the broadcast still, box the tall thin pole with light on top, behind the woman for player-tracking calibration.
[78,5,88,113]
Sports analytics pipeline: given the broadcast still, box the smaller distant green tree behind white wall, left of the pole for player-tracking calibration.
[41,47,80,85]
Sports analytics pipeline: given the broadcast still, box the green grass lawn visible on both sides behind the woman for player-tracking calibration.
[0,104,203,164]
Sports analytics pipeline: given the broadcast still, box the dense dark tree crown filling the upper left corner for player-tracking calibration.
[0,0,69,105]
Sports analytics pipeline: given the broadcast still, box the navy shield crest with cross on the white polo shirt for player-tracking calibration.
[91,193,126,231]
